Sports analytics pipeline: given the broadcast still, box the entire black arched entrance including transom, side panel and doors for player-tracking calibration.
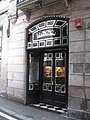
[26,16,69,108]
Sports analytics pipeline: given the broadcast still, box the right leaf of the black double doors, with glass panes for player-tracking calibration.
[54,52,68,107]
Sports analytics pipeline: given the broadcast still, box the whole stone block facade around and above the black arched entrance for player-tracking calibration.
[0,0,90,120]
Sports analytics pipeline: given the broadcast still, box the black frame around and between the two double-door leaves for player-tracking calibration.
[40,48,69,108]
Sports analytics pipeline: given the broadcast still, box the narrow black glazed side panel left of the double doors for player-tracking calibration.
[27,53,40,103]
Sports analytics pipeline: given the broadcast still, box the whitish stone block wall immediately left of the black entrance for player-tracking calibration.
[7,13,26,102]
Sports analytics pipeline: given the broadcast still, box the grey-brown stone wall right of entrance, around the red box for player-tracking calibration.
[68,0,90,120]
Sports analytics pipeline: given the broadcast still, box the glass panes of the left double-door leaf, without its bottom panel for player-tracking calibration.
[43,53,53,91]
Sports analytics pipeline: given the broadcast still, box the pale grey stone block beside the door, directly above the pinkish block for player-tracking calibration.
[69,75,83,86]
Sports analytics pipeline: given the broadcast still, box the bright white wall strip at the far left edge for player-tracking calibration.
[0,14,8,96]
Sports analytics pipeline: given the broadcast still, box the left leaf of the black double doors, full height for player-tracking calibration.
[42,53,54,103]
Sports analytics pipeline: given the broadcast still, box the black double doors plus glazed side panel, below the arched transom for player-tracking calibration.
[27,50,68,107]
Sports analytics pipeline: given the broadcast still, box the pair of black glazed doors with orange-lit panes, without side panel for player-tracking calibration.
[41,51,68,107]
